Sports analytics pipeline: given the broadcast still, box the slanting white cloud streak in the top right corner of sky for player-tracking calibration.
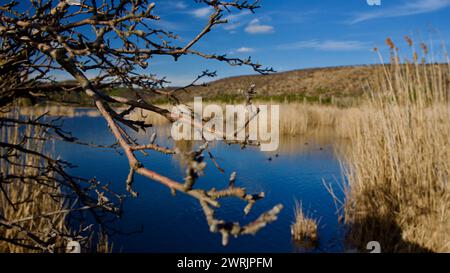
[350,0,450,24]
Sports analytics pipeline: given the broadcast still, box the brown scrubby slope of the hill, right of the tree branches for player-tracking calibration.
[182,66,377,98]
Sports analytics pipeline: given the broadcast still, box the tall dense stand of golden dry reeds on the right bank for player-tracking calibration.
[345,37,450,252]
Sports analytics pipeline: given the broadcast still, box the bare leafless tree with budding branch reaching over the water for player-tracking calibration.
[0,0,282,245]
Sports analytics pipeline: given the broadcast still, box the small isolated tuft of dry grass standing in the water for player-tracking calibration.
[291,201,318,243]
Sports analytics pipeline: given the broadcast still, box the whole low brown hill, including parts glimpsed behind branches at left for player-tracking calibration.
[38,66,380,106]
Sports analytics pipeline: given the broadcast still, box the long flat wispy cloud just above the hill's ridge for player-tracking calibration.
[277,40,369,51]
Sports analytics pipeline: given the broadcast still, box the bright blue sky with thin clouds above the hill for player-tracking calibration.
[146,0,450,85]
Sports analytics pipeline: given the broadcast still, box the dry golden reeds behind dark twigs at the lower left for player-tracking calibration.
[0,111,112,253]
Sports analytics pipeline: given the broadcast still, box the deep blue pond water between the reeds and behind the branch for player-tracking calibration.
[55,113,343,252]
